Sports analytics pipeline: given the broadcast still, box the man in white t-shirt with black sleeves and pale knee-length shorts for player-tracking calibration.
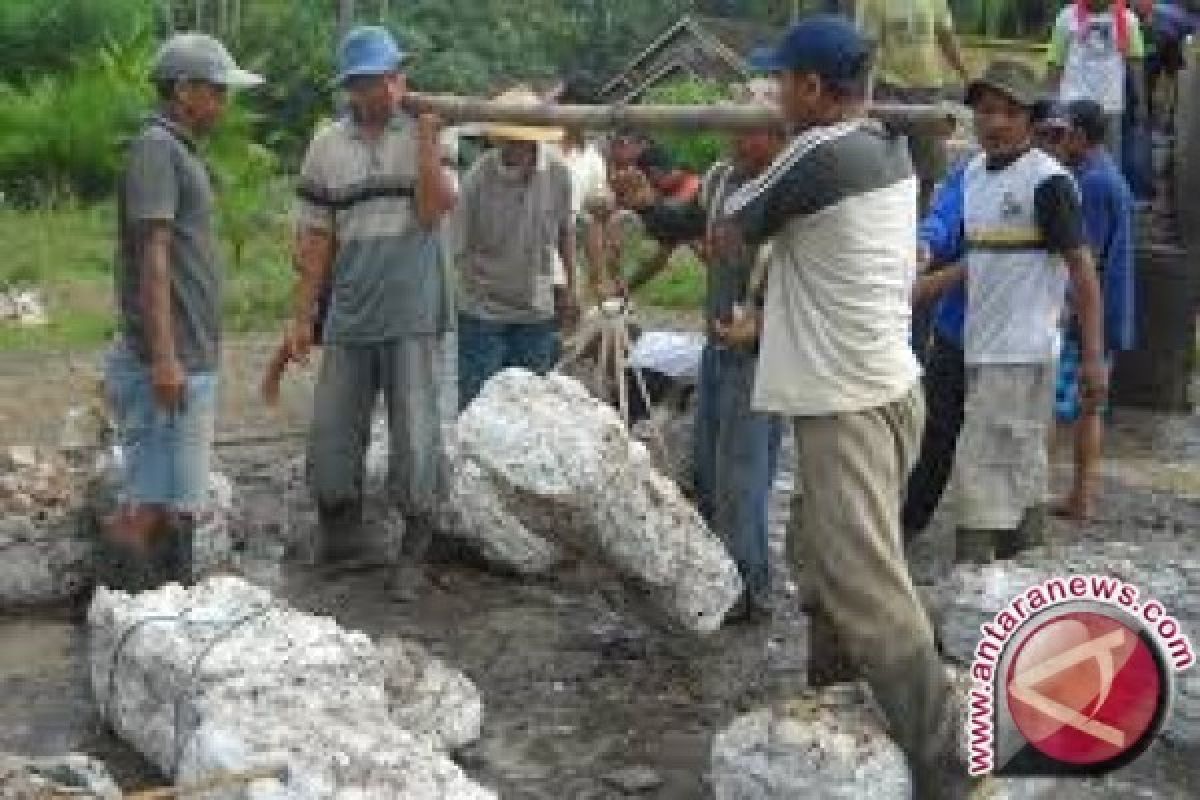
[925,61,1108,563]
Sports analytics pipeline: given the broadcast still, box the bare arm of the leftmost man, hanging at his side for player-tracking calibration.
[140,221,186,409]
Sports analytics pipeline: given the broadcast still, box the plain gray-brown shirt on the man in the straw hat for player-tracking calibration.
[460,146,574,323]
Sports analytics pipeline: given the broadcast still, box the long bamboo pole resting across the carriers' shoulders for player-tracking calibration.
[406,92,966,134]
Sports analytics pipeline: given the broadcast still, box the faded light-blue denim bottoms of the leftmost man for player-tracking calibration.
[104,344,217,513]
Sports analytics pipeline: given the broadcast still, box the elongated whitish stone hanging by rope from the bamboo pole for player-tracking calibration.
[454,369,742,633]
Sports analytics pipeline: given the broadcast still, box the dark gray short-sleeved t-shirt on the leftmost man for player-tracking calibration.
[116,118,222,373]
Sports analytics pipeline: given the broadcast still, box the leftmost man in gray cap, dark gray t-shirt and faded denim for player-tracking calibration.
[106,34,263,581]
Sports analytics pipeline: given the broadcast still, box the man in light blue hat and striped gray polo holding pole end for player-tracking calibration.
[288,28,456,561]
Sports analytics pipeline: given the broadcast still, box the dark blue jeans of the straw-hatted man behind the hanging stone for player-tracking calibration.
[458,314,559,410]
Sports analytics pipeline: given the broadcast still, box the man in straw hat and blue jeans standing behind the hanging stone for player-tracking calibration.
[458,89,575,408]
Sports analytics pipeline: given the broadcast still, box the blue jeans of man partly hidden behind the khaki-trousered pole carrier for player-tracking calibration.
[695,344,784,600]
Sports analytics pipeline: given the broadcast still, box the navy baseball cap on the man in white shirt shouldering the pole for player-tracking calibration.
[750,14,871,83]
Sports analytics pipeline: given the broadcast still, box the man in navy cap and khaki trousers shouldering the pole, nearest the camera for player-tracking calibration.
[725,14,968,800]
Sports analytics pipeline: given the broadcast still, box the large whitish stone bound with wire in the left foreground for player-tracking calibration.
[89,576,494,800]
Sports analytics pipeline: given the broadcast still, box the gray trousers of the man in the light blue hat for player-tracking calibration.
[308,335,442,513]
